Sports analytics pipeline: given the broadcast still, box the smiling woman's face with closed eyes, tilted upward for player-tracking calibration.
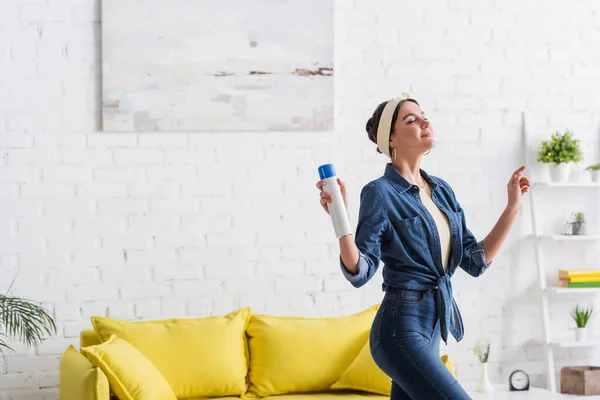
[390,101,435,155]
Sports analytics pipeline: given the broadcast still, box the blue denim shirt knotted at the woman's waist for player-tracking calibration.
[340,164,491,344]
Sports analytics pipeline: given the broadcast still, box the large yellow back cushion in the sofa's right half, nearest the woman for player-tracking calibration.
[247,305,379,397]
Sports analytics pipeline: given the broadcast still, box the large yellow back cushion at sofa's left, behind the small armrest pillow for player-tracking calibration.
[92,308,250,399]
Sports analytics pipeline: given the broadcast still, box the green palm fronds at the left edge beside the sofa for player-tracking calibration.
[0,279,56,354]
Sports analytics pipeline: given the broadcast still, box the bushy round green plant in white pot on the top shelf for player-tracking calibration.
[537,130,583,182]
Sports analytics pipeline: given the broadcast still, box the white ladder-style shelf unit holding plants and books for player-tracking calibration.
[522,115,600,392]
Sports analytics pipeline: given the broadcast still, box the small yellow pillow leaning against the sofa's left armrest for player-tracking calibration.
[81,335,177,400]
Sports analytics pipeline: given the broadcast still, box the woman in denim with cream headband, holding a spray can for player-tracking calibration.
[317,95,529,400]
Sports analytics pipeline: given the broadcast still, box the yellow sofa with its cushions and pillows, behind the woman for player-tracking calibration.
[60,305,455,400]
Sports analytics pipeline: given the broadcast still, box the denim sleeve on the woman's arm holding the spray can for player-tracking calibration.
[340,184,388,287]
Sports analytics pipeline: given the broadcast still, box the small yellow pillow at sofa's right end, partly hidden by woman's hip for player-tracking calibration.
[331,340,456,396]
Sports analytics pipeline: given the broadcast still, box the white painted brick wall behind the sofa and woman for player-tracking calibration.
[0,0,600,400]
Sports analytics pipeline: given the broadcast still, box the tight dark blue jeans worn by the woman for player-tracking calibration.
[369,288,471,400]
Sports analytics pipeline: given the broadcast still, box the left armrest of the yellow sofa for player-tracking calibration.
[59,346,110,400]
